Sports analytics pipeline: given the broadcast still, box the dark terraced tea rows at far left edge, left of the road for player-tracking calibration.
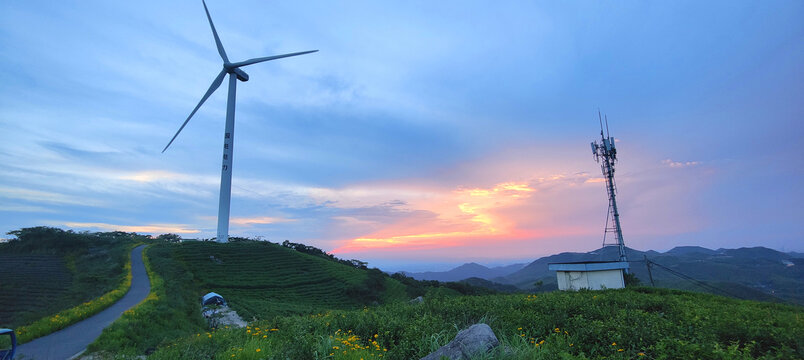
[0,255,72,327]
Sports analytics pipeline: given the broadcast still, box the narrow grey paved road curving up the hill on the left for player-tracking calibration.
[15,245,151,360]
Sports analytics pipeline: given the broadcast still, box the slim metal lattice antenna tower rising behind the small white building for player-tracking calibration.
[592,111,628,264]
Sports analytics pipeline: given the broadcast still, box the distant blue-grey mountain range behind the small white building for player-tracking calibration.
[398,246,804,305]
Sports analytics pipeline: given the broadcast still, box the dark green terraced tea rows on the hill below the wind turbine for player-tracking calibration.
[172,242,406,320]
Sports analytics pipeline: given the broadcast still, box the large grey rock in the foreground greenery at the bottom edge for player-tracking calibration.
[421,324,500,360]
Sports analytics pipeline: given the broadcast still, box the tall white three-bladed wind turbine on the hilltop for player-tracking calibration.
[162,0,318,242]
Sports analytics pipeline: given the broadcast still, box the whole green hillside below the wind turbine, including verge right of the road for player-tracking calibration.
[89,242,407,355]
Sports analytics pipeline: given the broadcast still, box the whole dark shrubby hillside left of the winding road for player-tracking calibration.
[0,227,138,327]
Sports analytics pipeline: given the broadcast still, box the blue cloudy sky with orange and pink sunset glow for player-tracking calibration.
[0,0,804,271]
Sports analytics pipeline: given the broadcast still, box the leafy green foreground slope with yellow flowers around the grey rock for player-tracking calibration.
[146,288,804,359]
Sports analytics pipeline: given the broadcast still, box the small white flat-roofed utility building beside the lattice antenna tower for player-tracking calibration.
[547,261,628,291]
